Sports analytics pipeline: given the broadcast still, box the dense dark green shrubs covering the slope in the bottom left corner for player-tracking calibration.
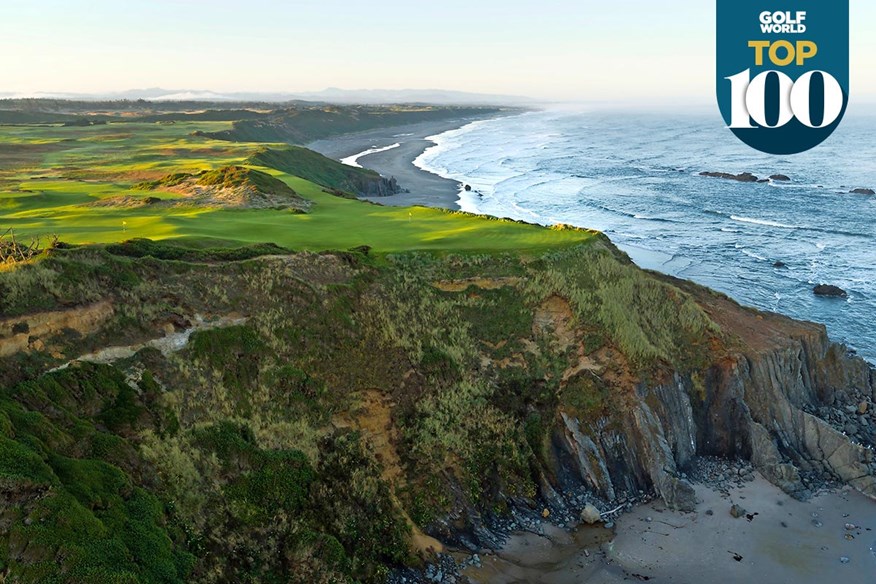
[0,364,194,584]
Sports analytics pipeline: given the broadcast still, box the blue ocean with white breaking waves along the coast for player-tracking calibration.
[415,111,876,363]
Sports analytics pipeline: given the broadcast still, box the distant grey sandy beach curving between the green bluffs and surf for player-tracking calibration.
[307,118,484,209]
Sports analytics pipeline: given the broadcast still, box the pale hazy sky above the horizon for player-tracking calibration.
[0,0,876,100]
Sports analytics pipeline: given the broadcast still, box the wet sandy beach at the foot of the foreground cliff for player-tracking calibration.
[463,475,876,584]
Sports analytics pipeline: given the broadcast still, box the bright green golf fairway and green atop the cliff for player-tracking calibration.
[0,122,592,252]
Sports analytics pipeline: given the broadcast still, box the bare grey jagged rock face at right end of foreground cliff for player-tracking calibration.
[553,327,876,510]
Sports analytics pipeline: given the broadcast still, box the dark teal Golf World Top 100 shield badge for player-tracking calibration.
[716,0,849,154]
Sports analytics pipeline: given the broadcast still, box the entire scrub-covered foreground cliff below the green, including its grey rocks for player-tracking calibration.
[0,237,876,582]
